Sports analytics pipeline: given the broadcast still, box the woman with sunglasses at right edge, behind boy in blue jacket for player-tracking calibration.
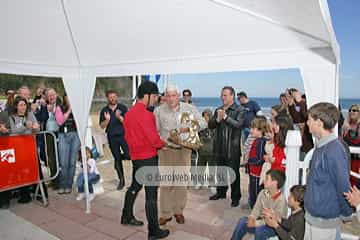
[343,104,360,186]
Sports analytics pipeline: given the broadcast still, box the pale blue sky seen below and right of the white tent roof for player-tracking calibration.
[171,0,360,98]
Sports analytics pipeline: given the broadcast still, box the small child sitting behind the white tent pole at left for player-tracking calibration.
[76,147,100,201]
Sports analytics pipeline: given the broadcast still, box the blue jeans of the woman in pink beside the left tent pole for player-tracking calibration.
[59,132,80,189]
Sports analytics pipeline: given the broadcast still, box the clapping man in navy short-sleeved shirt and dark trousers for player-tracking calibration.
[99,90,130,190]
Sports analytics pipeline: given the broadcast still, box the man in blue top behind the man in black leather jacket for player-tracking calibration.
[237,92,263,143]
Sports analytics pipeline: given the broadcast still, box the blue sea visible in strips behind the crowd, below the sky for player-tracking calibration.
[192,97,360,117]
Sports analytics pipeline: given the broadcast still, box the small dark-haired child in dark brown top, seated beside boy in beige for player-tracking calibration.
[263,185,306,240]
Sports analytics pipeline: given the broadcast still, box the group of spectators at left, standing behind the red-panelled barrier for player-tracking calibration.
[0,86,80,208]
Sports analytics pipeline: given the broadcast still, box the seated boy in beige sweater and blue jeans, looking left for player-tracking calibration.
[231,170,287,240]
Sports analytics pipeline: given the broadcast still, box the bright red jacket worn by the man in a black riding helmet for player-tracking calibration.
[123,102,165,160]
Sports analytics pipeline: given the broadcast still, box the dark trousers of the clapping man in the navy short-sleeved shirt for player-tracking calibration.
[108,136,130,180]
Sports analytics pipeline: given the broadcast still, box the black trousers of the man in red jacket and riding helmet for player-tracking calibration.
[122,156,159,234]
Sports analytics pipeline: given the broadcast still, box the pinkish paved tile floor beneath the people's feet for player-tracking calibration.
[5,153,360,240]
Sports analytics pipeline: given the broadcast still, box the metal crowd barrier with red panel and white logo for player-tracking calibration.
[0,131,60,206]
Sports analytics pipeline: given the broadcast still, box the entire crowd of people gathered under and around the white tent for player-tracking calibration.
[0,81,360,239]
